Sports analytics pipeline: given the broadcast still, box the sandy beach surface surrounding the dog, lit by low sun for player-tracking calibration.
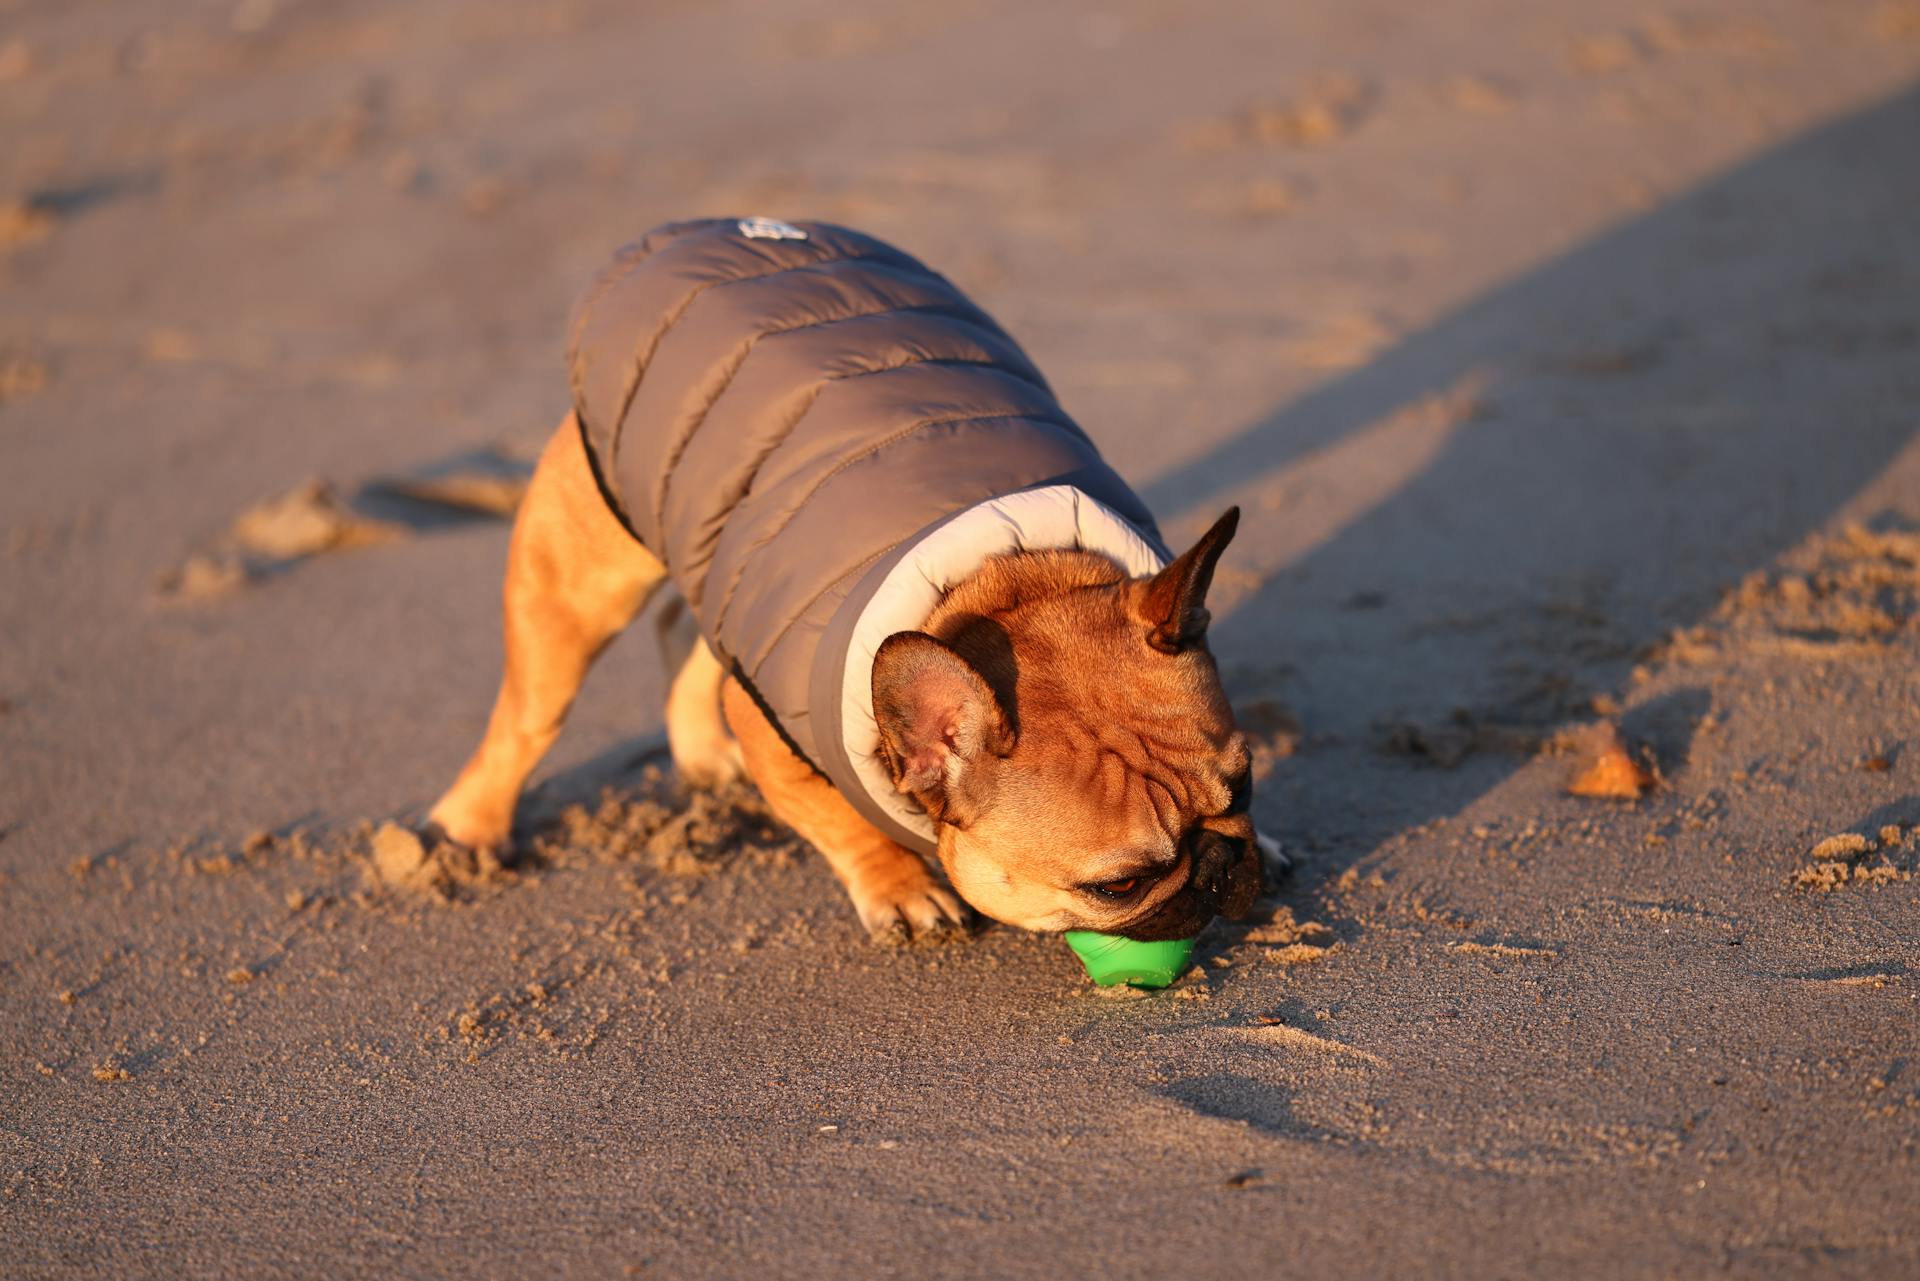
[0,0,1920,1279]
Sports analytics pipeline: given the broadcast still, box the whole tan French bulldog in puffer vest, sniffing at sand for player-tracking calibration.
[428,219,1277,941]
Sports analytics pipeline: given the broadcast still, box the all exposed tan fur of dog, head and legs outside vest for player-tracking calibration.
[428,417,1258,941]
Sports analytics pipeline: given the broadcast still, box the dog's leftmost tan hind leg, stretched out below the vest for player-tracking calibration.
[428,415,666,855]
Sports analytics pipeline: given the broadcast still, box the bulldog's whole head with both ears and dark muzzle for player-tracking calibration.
[874,511,1260,939]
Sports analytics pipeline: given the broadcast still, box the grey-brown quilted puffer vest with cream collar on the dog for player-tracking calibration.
[568,219,1165,849]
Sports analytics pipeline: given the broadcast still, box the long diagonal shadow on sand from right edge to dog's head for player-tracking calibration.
[1142,88,1920,871]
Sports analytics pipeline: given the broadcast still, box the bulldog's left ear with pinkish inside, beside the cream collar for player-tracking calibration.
[874,632,1014,816]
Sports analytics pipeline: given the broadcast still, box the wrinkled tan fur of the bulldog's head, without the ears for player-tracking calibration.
[894,551,1252,933]
